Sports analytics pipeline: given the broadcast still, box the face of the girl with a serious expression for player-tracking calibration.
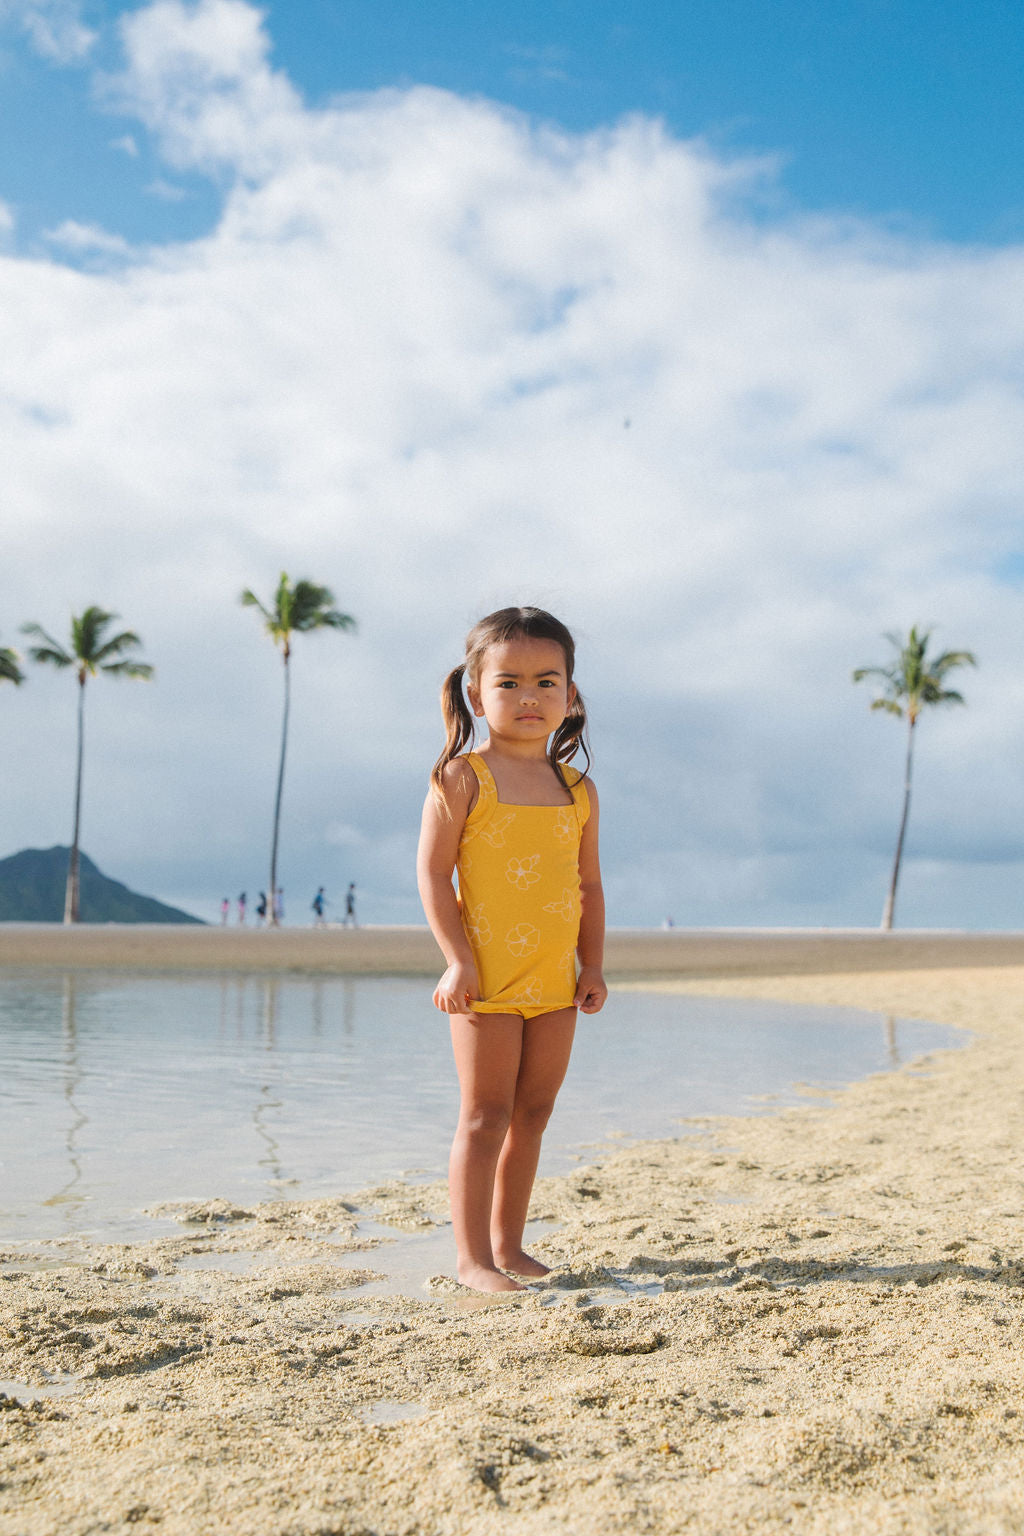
[467,636,576,745]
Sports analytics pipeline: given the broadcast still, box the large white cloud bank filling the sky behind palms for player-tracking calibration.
[0,0,1024,923]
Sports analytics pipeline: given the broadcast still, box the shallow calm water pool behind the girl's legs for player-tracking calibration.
[0,972,964,1243]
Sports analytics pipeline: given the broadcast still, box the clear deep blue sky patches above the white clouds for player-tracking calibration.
[0,0,1024,244]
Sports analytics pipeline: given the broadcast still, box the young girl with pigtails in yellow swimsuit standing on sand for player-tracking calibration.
[418,608,608,1290]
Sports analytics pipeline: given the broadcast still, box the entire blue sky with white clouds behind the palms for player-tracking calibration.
[0,0,1024,928]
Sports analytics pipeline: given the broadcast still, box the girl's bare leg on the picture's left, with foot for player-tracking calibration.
[448,1014,524,1290]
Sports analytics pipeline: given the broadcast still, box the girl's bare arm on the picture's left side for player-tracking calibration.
[416,760,481,1014]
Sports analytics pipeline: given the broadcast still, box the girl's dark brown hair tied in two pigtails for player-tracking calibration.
[430,608,590,803]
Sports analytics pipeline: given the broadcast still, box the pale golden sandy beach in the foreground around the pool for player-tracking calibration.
[0,931,1024,1536]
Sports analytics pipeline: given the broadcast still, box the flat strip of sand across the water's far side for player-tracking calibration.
[0,923,1024,982]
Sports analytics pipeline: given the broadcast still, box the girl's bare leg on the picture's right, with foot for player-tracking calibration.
[491,1008,576,1276]
